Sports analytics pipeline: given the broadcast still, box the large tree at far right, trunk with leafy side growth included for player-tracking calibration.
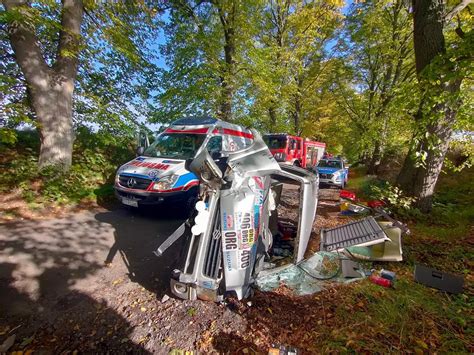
[398,0,474,212]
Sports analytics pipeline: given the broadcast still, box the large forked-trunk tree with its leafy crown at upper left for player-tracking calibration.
[0,1,166,170]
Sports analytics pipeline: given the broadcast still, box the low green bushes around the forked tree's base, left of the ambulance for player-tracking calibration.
[0,130,133,205]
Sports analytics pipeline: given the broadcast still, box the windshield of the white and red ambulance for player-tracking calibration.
[143,133,206,159]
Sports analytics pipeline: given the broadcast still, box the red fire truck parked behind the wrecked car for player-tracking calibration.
[263,133,326,169]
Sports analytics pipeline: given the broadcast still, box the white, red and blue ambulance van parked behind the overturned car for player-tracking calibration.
[115,117,253,208]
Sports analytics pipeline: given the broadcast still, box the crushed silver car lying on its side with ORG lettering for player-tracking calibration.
[159,125,318,301]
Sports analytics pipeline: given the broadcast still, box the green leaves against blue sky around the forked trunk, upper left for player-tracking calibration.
[0,1,160,137]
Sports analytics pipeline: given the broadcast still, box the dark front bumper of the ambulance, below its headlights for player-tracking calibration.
[114,186,198,206]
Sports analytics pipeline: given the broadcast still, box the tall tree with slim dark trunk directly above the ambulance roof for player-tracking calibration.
[159,0,259,121]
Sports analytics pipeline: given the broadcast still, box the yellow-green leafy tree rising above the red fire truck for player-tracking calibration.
[250,0,342,134]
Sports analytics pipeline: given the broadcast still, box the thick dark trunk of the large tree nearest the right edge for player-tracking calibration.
[397,0,461,212]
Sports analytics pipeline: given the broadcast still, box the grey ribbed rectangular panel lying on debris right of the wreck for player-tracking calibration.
[320,217,387,251]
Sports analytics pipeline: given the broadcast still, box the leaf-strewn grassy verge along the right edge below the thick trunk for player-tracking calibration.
[326,168,474,353]
